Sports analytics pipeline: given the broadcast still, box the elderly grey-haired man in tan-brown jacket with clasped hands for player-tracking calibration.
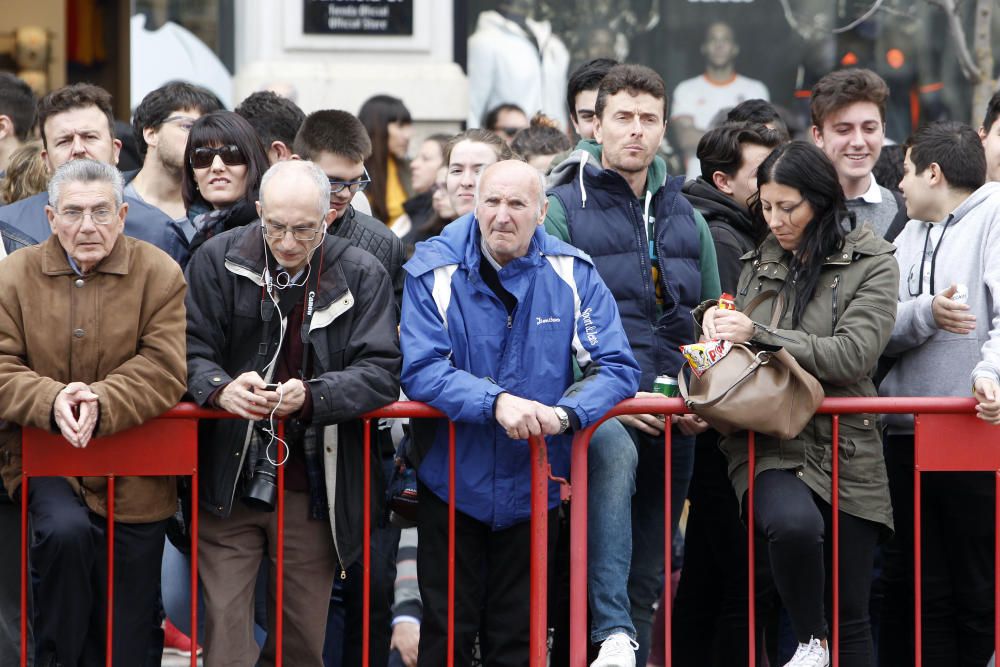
[0,160,186,665]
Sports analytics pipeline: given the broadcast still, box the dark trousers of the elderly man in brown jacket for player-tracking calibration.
[28,477,166,667]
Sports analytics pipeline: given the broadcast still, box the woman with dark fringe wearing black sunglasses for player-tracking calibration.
[181,111,268,252]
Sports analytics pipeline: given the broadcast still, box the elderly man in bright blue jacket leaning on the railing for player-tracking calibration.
[400,160,639,667]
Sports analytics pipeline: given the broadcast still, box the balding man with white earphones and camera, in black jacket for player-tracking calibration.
[187,160,401,667]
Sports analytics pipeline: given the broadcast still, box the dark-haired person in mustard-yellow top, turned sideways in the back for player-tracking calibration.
[358,95,413,225]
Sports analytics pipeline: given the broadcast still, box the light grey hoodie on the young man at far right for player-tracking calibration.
[879,183,1000,434]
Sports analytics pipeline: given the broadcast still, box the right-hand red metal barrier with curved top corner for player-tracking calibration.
[569,397,984,667]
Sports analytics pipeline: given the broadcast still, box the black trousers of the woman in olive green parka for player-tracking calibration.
[754,470,880,667]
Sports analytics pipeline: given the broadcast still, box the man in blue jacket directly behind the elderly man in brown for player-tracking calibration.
[0,83,187,261]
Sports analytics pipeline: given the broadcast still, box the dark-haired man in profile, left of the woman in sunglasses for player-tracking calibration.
[125,81,223,222]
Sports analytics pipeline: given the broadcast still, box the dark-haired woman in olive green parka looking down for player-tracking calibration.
[695,141,899,667]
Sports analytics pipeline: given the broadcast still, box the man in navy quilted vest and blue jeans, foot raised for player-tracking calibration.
[545,65,720,667]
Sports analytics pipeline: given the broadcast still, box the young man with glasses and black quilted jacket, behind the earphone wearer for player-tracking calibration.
[293,109,405,316]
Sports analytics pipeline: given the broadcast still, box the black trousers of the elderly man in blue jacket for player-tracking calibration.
[417,484,557,667]
